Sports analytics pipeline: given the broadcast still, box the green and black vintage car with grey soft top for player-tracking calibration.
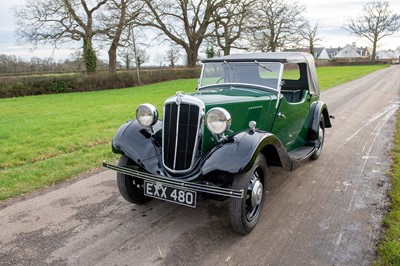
[103,52,332,234]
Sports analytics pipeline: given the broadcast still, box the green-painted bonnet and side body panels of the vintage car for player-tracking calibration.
[190,86,318,154]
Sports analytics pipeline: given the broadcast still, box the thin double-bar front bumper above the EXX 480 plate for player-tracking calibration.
[103,161,244,199]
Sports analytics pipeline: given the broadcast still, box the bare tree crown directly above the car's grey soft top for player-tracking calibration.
[251,0,305,52]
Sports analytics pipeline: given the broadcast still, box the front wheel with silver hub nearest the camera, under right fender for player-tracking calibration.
[229,154,268,235]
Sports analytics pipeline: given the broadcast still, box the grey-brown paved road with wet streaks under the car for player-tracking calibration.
[0,66,400,265]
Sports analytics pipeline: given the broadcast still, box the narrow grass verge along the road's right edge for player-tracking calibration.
[375,112,400,266]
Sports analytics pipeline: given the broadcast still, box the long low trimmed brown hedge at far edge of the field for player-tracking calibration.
[0,68,200,98]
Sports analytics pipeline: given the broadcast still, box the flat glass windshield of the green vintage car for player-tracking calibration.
[199,61,282,90]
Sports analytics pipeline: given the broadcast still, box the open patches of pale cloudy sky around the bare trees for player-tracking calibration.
[0,0,400,64]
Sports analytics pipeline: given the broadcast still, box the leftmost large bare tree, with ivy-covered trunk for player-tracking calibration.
[14,0,110,73]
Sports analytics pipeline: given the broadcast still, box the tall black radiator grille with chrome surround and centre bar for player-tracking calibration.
[163,102,201,172]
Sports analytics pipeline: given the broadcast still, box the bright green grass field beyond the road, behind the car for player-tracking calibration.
[0,66,385,200]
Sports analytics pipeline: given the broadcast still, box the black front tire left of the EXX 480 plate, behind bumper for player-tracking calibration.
[117,155,153,204]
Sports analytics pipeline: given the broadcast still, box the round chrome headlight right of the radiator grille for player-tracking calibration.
[206,107,231,135]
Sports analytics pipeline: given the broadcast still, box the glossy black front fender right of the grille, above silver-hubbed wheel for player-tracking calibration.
[201,131,292,174]
